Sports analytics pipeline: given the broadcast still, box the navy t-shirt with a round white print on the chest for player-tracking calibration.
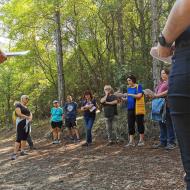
[63,102,77,119]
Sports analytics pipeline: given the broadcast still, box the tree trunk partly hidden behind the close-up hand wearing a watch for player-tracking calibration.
[151,0,161,87]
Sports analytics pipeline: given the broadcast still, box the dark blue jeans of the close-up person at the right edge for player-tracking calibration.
[168,47,190,190]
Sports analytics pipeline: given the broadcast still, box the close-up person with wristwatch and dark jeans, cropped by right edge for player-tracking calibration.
[154,0,190,190]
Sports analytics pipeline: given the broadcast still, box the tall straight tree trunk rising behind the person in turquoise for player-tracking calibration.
[55,10,65,104]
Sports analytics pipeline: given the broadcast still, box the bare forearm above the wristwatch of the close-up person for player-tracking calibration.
[163,0,190,43]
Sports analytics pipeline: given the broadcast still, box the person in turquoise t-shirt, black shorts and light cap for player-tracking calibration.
[51,100,63,144]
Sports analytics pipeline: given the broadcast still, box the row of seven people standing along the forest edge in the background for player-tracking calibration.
[11,69,176,160]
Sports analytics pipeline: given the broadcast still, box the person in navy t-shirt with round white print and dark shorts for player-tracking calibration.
[63,95,80,142]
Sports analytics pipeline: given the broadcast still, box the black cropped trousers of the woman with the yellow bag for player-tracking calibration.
[127,110,144,135]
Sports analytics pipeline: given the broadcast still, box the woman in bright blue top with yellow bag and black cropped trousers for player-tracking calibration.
[124,75,145,147]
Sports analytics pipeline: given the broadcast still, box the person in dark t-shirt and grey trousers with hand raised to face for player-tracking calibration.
[100,85,118,145]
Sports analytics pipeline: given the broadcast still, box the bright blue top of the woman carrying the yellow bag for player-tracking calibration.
[127,84,143,110]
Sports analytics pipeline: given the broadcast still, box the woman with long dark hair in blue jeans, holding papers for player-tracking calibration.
[81,91,96,146]
